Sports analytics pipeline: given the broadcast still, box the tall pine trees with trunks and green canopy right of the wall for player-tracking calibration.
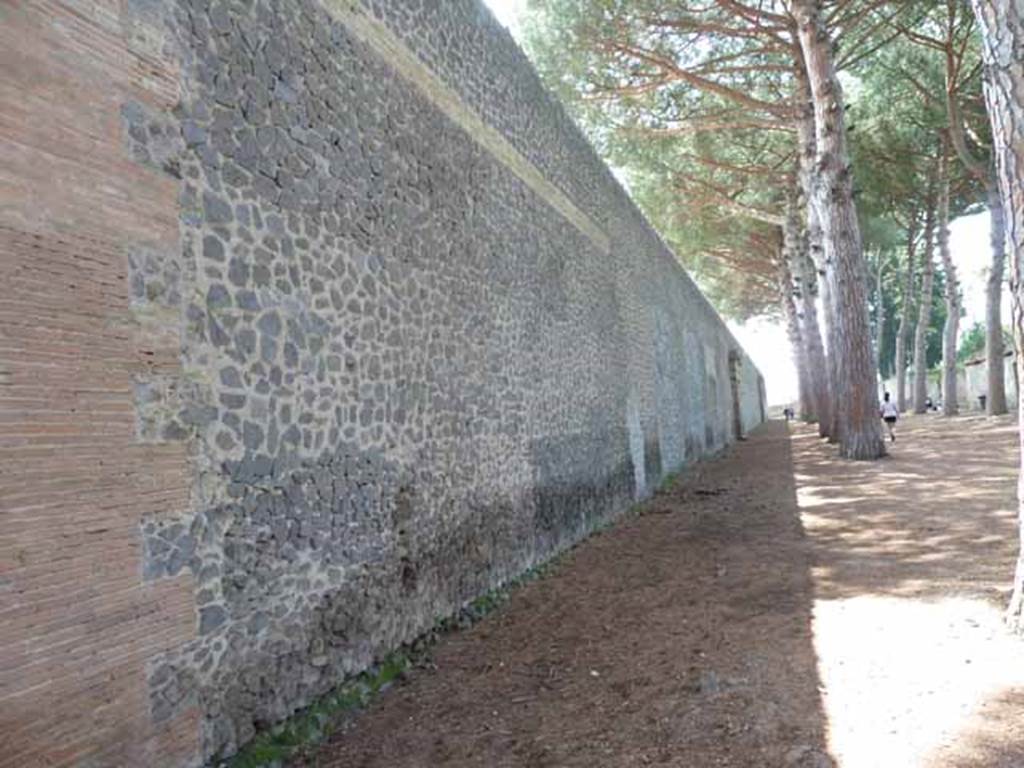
[526,0,1024,628]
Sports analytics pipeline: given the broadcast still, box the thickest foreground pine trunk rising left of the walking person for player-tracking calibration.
[793,0,886,459]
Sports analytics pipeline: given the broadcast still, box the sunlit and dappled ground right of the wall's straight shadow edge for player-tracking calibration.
[794,416,1024,768]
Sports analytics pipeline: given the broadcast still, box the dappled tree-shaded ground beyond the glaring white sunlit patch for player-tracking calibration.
[794,417,1019,605]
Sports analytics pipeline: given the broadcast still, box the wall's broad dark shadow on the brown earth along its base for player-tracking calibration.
[305,422,831,768]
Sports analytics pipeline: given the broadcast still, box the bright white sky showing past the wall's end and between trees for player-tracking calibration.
[484,0,1010,404]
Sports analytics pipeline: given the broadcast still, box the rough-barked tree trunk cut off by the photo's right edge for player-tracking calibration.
[973,0,1024,630]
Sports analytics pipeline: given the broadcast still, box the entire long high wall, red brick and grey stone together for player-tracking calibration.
[0,0,763,766]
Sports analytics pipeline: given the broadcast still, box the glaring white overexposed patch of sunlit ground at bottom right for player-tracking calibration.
[814,595,1024,768]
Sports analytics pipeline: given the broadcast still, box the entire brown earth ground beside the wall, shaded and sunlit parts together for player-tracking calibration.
[302,417,1024,768]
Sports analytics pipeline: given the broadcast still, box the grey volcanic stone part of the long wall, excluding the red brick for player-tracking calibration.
[144,0,761,760]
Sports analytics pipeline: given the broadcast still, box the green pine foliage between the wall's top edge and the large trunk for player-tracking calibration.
[525,0,795,321]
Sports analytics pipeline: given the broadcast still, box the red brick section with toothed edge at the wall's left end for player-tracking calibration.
[0,0,199,768]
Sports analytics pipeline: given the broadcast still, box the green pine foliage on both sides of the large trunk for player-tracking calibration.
[524,0,987,337]
